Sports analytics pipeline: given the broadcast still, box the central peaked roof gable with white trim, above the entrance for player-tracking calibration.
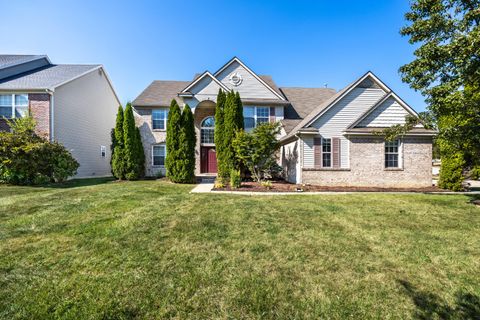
[213,57,286,101]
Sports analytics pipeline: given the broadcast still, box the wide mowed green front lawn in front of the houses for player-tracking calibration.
[0,179,480,319]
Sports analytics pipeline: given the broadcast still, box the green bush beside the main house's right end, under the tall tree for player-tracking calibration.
[438,152,465,191]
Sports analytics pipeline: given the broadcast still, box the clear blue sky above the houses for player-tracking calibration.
[0,0,425,111]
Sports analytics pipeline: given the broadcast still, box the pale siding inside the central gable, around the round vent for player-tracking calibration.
[217,61,279,99]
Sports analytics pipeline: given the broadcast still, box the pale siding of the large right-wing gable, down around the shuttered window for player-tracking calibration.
[303,88,386,168]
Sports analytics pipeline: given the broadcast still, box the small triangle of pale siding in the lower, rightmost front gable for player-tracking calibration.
[357,97,409,128]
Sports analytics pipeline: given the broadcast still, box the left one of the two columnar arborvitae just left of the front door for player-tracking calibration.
[165,99,182,182]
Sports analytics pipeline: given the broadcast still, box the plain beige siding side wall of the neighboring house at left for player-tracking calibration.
[54,70,119,178]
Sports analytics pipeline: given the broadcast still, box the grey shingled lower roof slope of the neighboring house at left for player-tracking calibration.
[0,64,101,90]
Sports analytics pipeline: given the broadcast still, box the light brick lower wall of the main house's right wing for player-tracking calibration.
[302,137,432,188]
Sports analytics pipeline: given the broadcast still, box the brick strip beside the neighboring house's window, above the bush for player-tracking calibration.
[28,93,50,139]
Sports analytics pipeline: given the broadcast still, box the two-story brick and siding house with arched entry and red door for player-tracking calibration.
[133,57,435,187]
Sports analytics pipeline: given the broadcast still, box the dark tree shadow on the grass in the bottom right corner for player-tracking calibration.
[398,280,480,320]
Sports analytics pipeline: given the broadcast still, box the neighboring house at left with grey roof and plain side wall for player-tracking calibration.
[0,55,120,178]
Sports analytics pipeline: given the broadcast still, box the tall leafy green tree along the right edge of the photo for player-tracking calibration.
[400,0,480,190]
